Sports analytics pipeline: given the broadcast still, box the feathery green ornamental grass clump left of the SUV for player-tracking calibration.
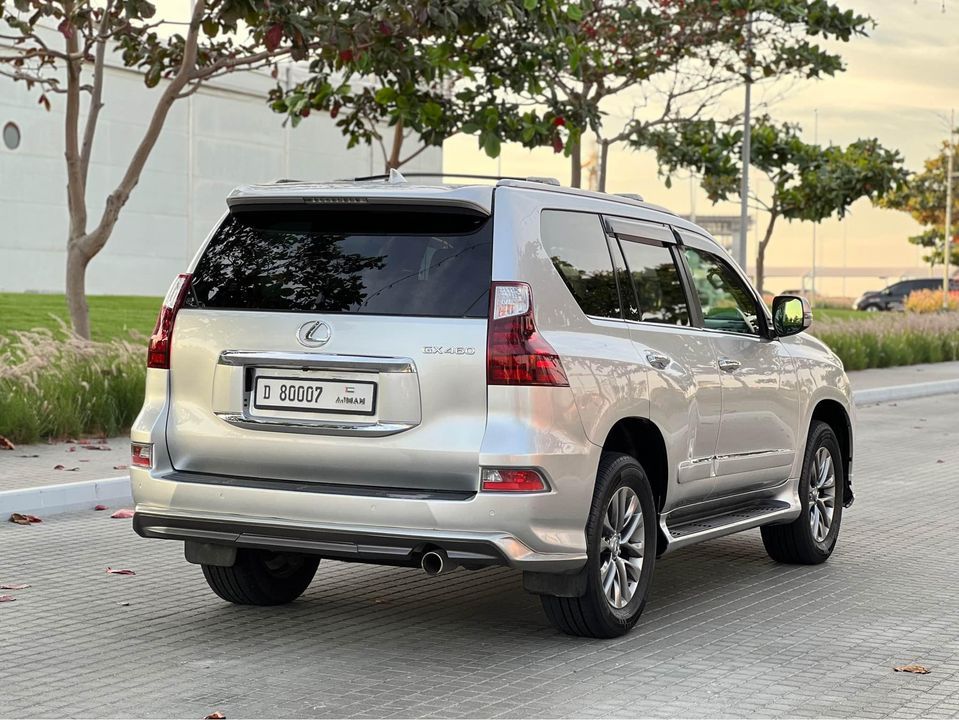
[0,329,146,442]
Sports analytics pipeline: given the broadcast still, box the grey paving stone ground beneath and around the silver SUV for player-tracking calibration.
[0,396,959,718]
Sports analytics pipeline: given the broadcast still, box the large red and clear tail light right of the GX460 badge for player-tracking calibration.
[486,282,569,387]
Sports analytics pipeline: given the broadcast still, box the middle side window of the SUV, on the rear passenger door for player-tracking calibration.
[620,239,689,325]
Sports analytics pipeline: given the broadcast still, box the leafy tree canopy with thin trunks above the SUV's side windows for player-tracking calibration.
[479,0,871,189]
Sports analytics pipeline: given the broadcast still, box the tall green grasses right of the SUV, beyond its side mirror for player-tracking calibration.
[810,313,959,371]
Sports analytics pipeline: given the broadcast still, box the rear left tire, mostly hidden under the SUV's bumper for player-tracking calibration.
[202,550,320,605]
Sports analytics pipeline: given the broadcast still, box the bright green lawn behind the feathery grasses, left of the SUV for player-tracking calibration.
[0,293,163,341]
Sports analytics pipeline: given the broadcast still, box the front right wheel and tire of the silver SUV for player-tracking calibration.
[760,420,846,565]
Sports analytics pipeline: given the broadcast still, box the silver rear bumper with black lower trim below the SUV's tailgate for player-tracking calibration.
[130,468,592,573]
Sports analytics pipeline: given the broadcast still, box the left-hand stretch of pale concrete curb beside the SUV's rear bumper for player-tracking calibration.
[0,475,133,520]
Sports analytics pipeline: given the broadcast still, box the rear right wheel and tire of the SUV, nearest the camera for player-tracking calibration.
[540,453,656,638]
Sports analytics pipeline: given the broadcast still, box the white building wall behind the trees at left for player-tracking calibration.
[0,62,442,295]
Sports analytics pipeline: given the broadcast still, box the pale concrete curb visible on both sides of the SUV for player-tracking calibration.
[0,379,959,517]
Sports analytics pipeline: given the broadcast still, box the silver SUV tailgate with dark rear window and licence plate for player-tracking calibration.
[167,202,492,491]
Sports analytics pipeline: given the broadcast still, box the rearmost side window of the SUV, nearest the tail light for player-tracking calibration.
[540,210,622,320]
